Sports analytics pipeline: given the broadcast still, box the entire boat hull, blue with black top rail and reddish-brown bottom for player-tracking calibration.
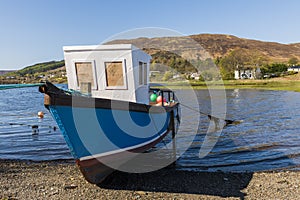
[40,83,180,183]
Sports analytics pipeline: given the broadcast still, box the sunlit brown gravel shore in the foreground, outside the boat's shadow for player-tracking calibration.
[0,160,300,200]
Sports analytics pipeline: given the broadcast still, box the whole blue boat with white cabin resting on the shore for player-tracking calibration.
[39,44,180,184]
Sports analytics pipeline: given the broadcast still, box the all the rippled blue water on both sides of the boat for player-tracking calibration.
[0,88,300,171]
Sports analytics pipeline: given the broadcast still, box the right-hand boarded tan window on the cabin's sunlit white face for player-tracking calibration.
[105,61,126,89]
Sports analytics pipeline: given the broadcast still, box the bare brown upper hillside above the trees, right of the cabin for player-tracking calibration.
[108,34,300,62]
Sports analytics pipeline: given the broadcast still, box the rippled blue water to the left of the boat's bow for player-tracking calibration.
[0,87,72,160]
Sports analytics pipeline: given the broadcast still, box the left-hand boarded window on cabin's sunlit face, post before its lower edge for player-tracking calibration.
[75,62,97,89]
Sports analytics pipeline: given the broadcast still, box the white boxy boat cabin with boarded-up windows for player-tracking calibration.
[63,44,151,104]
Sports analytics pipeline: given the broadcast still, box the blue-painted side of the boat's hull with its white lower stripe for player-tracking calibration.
[49,105,170,160]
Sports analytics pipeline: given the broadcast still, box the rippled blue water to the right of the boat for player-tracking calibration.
[178,89,300,171]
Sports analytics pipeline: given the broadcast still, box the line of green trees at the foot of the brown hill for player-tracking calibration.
[151,48,299,80]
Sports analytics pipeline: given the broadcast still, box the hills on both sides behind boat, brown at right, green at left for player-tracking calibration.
[0,34,300,84]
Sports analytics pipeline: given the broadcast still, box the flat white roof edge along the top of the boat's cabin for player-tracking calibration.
[63,44,140,52]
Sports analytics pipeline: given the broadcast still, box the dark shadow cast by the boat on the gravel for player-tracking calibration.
[98,168,253,199]
